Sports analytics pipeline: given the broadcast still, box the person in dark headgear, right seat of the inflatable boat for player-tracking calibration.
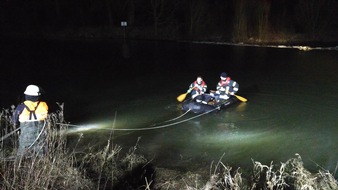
[210,72,239,102]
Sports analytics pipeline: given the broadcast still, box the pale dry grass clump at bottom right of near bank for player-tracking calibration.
[173,154,338,190]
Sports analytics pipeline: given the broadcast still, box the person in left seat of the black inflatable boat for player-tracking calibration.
[187,76,208,104]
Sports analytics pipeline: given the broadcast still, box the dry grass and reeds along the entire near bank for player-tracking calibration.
[0,104,338,190]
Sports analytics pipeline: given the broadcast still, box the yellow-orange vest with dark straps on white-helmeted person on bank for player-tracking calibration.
[19,100,48,122]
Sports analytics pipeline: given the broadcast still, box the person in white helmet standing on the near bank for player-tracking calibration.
[12,85,48,157]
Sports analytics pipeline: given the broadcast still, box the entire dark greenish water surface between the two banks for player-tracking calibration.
[0,40,338,178]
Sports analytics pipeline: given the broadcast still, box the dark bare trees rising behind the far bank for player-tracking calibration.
[0,0,338,42]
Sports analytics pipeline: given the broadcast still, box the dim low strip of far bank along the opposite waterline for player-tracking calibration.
[0,27,338,49]
